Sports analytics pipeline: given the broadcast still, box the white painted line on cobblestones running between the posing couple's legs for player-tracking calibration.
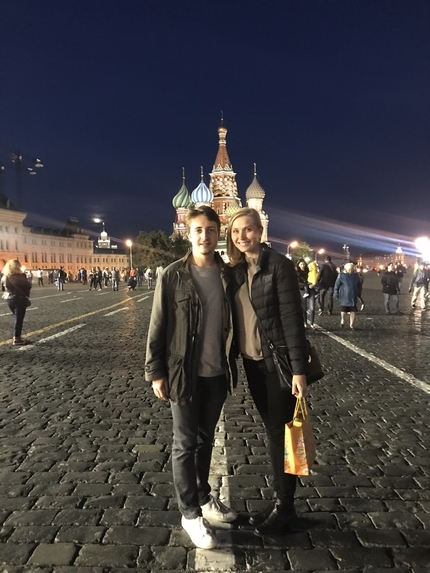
[194,408,236,571]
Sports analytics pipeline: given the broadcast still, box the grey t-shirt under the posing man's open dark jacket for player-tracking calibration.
[190,263,225,378]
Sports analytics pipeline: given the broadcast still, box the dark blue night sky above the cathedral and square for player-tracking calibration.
[0,0,430,253]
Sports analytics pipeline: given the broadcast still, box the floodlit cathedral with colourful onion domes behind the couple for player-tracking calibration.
[172,123,269,250]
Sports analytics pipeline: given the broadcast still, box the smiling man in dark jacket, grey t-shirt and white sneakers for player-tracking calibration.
[145,206,237,549]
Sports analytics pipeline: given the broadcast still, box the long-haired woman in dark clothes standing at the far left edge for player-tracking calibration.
[2,259,31,346]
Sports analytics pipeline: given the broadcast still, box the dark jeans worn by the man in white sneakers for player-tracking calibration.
[171,375,227,519]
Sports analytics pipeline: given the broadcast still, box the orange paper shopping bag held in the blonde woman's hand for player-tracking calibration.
[284,398,316,476]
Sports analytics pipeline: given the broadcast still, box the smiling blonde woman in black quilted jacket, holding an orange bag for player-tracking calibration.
[227,208,308,536]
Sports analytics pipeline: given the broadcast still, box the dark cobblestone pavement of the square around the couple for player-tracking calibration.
[0,273,430,573]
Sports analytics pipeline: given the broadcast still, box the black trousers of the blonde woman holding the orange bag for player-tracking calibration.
[243,358,297,503]
